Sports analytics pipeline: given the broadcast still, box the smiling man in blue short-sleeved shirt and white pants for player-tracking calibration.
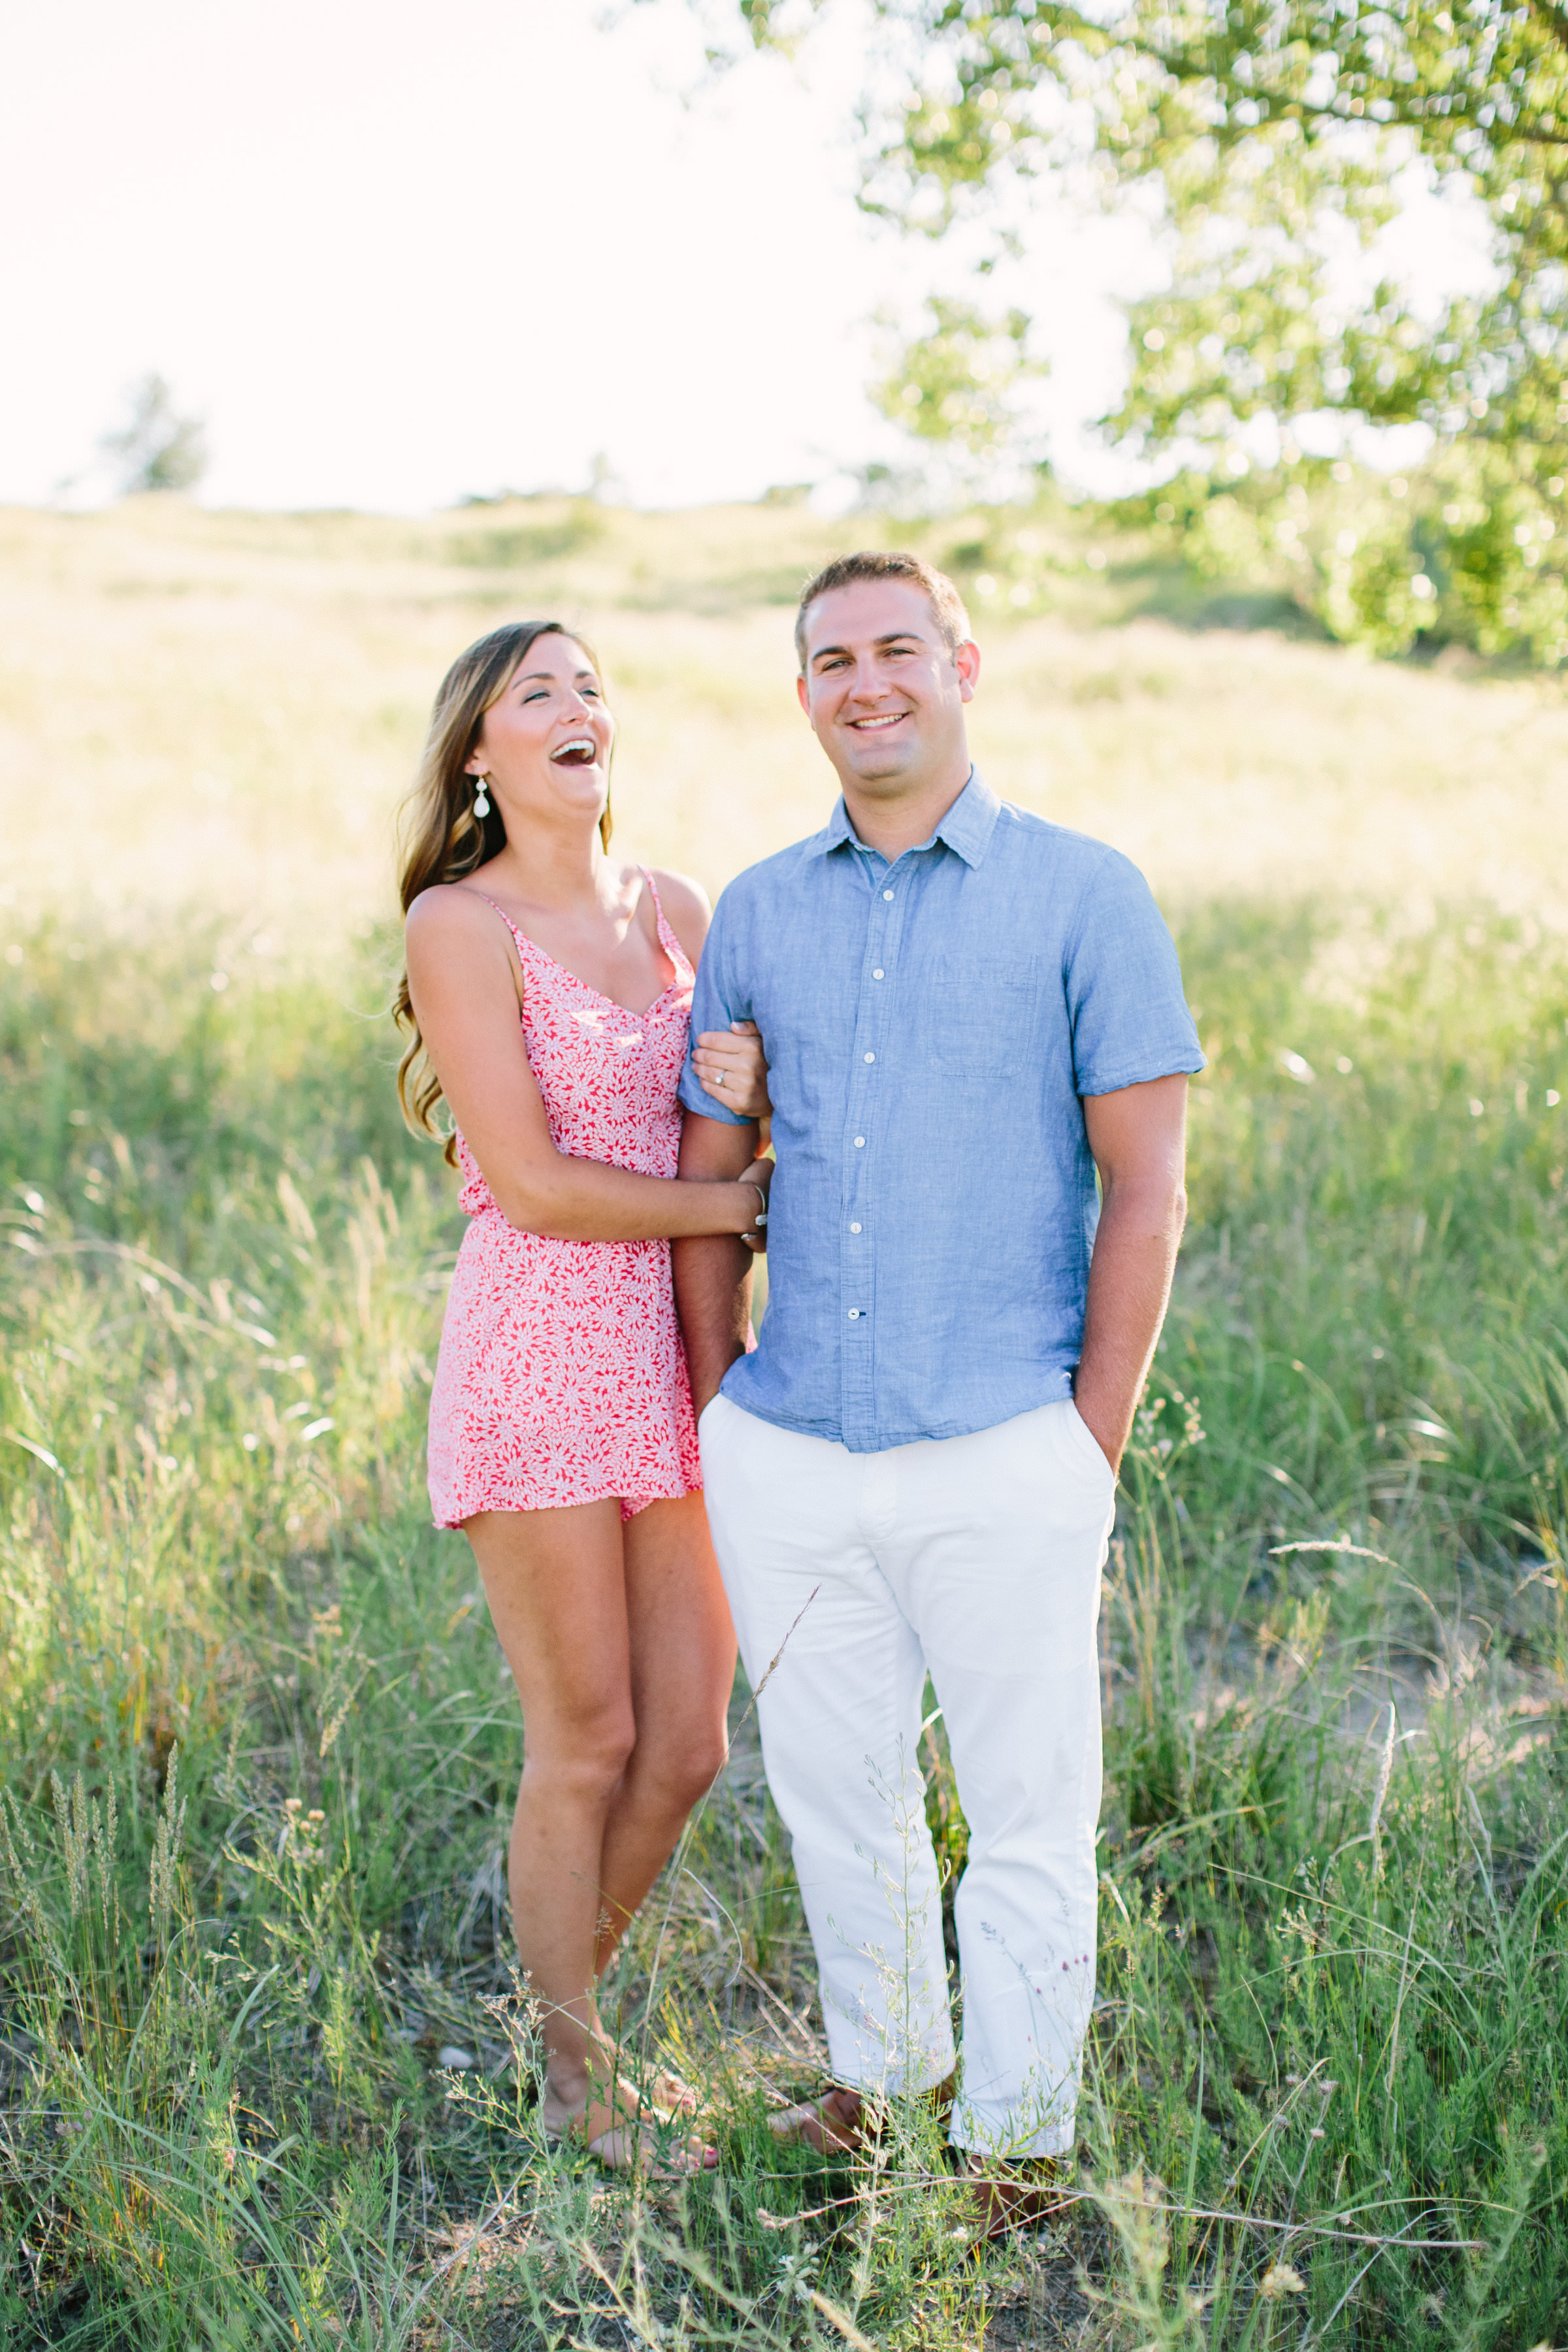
[675,555,1203,2220]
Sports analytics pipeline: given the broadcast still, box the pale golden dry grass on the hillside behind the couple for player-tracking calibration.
[0,498,1568,950]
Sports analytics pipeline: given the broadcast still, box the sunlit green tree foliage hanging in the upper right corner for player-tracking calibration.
[745,0,1568,661]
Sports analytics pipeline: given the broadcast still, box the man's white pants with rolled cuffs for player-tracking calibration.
[700,1397,1115,2157]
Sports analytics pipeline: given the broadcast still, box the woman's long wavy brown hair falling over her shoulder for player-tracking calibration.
[393,621,609,1167]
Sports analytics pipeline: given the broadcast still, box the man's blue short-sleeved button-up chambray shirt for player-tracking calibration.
[679,769,1203,1454]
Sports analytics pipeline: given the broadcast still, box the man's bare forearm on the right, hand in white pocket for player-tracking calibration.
[1081,1183,1187,1465]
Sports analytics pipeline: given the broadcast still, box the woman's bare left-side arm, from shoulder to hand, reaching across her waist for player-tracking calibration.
[406,887,771,1242]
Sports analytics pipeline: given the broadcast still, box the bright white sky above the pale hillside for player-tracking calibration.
[0,0,1495,510]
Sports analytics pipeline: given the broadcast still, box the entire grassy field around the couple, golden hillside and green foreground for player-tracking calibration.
[0,487,1568,2352]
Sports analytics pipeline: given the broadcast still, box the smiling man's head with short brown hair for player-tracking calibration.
[799,579,980,797]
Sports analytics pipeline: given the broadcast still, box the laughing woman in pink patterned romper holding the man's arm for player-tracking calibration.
[397,621,769,2171]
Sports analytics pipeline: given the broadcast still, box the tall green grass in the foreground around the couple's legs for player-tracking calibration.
[0,908,1568,2352]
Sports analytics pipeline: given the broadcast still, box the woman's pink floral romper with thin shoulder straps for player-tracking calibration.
[430,877,703,1526]
